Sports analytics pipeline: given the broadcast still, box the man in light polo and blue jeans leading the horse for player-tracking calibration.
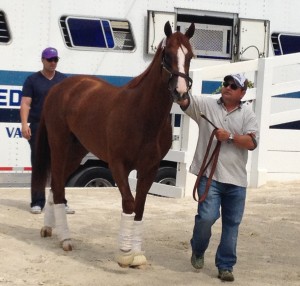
[178,74,258,281]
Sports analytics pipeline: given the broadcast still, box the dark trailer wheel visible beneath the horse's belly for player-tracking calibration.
[67,167,115,187]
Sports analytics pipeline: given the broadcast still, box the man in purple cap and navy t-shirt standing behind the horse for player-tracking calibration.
[20,48,75,214]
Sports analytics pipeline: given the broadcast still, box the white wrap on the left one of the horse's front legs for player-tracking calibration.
[119,213,134,252]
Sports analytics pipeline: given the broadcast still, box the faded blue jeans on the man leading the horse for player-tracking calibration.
[191,177,246,271]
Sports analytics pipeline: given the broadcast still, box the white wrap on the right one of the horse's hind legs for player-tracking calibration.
[54,204,71,241]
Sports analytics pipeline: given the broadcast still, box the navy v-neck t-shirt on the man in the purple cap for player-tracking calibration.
[22,71,67,123]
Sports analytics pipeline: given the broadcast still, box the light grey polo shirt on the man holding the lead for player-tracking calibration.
[185,96,259,187]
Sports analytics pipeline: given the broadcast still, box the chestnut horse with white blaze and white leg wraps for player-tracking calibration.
[32,22,195,267]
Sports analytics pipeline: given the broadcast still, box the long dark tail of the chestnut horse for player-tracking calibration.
[31,115,51,197]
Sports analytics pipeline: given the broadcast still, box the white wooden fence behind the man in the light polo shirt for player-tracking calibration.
[137,54,300,197]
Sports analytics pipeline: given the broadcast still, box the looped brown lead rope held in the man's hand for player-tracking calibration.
[193,125,221,203]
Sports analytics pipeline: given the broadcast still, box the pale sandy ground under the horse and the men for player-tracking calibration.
[0,182,300,286]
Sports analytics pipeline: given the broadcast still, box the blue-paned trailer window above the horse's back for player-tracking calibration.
[60,16,135,51]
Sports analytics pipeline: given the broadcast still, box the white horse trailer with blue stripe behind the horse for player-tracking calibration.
[0,0,300,196]
